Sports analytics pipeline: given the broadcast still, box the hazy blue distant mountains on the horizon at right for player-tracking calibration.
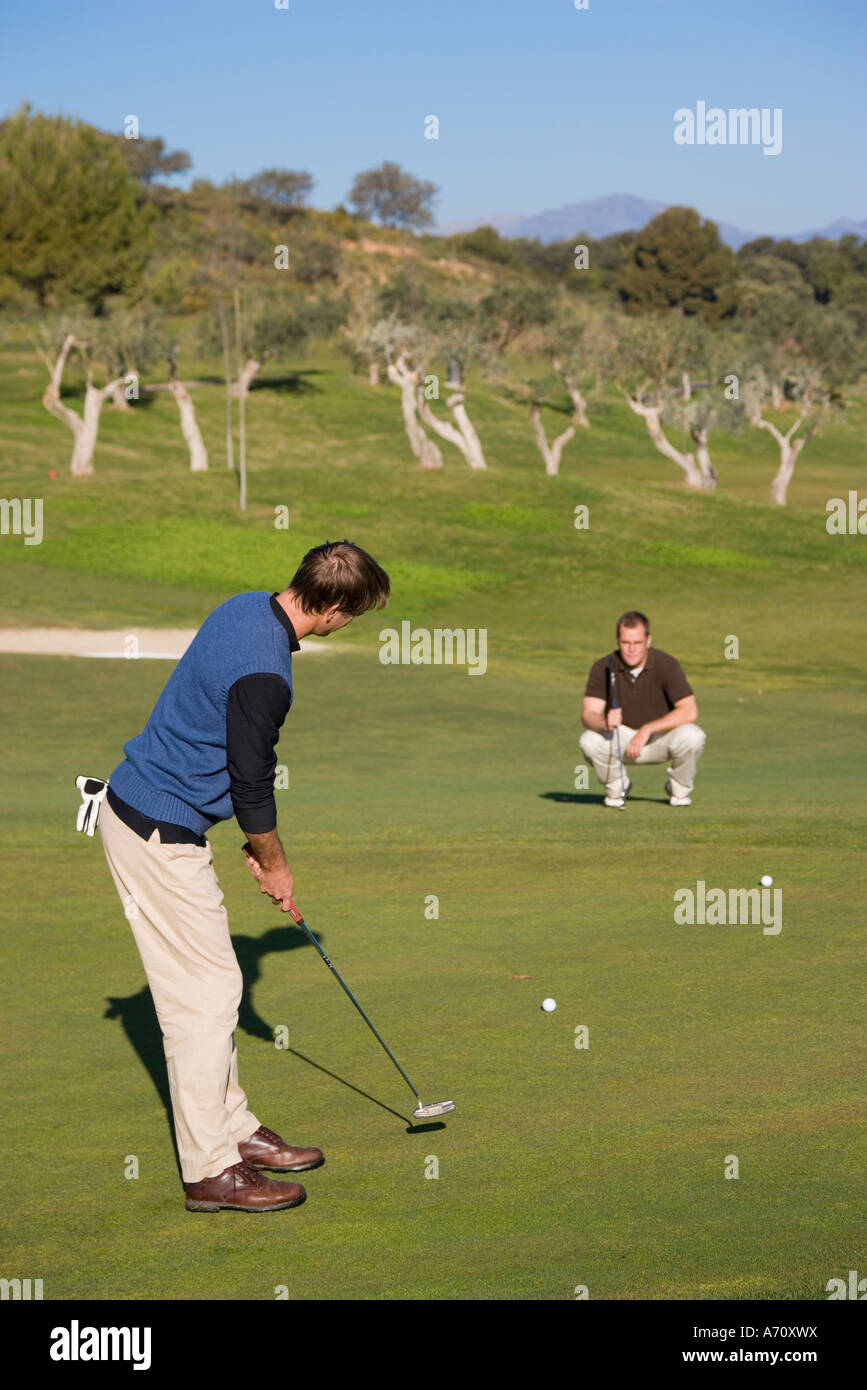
[436,193,867,250]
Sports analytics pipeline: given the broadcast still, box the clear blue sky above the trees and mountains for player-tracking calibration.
[0,0,867,235]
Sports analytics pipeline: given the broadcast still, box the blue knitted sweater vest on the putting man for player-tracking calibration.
[108,594,292,835]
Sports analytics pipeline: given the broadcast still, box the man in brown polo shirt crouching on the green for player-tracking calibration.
[581,612,704,806]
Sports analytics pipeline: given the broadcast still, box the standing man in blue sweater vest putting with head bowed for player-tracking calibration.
[97,541,389,1212]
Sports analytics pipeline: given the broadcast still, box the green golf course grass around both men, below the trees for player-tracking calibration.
[0,341,864,1298]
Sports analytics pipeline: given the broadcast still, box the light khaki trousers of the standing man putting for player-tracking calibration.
[99,801,258,1183]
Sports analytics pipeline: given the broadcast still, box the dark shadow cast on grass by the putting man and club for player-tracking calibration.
[103,926,422,1172]
